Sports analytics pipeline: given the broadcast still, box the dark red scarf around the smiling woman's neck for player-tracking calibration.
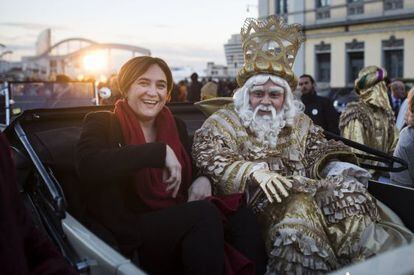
[114,100,192,210]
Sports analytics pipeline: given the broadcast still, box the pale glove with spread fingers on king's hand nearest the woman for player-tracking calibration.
[251,169,292,202]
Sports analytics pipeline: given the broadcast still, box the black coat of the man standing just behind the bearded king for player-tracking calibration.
[302,91,339,135]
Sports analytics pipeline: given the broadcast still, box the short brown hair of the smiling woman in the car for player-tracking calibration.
[117,56,173,97]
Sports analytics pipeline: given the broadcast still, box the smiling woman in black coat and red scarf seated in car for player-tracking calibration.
[77,56,265,274]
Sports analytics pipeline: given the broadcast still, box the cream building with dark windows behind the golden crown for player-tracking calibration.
[259,0,414,87]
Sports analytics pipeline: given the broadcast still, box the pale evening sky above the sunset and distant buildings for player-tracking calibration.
[0,0,258,71]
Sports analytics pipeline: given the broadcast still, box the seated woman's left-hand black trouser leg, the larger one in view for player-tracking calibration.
[133,201,224,275]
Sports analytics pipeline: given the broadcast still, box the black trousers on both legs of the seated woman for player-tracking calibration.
[128,201,267,274]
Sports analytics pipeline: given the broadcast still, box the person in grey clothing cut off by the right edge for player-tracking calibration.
[391,88,414,188]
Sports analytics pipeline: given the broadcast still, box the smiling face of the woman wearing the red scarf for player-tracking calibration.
[127,64,168,121]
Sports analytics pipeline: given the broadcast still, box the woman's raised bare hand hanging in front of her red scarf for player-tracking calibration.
[163,145,181,198]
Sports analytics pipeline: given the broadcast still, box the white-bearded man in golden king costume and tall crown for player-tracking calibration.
[193,16,413,274]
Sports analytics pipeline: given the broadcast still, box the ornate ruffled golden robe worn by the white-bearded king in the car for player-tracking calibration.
[193,104,411,274]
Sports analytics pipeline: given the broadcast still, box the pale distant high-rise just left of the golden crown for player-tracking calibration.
[224,34,244,77]
